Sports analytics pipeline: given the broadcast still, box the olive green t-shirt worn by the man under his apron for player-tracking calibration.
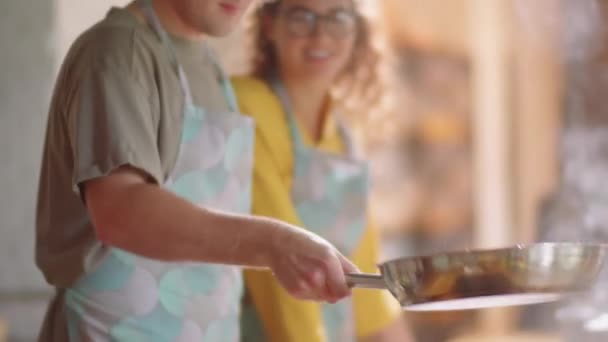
[36,8,228,289]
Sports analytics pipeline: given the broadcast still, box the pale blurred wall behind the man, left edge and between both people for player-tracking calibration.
[0,0,247,341]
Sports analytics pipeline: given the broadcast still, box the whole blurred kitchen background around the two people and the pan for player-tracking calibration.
[0,0,608,342]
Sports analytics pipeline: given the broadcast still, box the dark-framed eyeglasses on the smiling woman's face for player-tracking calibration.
[284,7,358,39]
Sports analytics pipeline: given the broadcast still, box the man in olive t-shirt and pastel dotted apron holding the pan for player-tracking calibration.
[36,0,357,341]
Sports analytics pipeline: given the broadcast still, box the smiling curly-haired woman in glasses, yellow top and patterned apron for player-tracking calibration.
[233,0,418,342]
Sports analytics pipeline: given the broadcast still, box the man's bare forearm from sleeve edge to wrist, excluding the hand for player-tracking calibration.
[87,175,286,267]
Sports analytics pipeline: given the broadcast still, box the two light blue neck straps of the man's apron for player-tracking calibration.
[139,0,238,112]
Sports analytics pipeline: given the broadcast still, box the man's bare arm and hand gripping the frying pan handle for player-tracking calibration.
[81,166,358,303]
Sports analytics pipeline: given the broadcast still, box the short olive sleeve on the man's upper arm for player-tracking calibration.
[69,57,163,190]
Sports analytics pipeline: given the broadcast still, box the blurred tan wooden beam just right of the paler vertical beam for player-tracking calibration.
[513,0,563,243]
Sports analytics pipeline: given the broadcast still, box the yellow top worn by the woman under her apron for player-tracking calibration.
[233,77,401,342]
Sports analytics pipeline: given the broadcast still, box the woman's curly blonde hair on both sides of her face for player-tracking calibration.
[246,0,388,139]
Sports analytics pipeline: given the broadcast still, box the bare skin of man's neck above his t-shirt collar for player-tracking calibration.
[127,0,205,41]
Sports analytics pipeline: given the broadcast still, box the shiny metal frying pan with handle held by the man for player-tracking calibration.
[347,242,606,311]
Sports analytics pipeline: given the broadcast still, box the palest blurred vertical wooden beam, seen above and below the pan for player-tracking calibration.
[469,0,514,334]
